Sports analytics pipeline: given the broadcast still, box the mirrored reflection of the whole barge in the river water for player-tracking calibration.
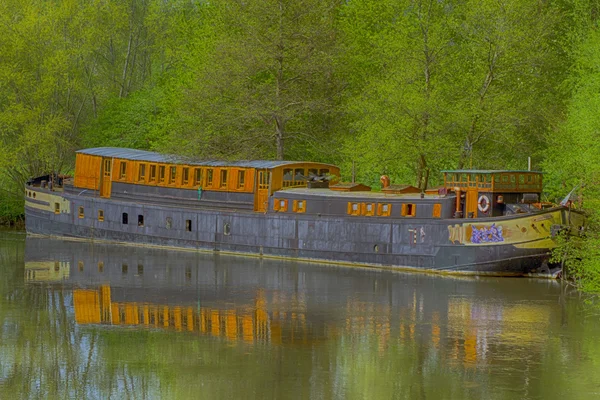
[25,238,558,365]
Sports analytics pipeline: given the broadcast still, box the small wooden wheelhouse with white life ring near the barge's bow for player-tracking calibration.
[442,170,543,217]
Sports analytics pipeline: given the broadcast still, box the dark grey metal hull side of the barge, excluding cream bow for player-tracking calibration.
[25,188,550,276]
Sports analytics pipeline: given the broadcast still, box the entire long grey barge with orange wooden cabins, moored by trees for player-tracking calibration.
[25,147,584,276]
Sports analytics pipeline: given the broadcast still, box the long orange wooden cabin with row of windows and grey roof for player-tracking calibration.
[73,147,340,211]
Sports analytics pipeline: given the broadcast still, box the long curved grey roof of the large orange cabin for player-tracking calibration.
[77,147,335,169]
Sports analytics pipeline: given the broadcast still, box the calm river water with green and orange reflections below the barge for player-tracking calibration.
[0,231,600,400]
